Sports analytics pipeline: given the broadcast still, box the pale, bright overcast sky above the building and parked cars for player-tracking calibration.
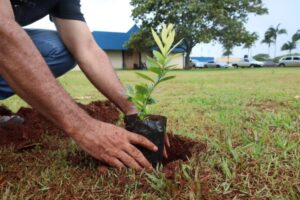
[28,0,300,57]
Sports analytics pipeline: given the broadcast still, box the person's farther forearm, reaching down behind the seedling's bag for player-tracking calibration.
[76,45,137,115]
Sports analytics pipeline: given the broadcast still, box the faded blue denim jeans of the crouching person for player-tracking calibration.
[0,29,76,100]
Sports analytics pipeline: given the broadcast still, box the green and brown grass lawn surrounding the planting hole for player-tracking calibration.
[0,68,300,199]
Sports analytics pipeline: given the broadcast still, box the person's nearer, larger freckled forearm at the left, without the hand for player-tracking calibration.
[0,21,87,134]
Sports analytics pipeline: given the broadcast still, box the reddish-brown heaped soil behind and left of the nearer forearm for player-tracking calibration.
[0,101,119,148]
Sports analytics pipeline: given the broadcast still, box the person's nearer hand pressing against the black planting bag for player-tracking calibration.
[74,120,157,170]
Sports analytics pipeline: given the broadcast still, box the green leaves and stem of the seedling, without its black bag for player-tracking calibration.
[127,24,181,120]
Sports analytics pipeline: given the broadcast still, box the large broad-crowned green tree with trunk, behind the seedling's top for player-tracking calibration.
[131,0,267,68]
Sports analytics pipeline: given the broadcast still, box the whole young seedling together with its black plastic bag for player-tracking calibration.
[125,24,181,167]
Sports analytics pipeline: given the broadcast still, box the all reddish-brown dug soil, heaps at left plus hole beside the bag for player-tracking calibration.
[0,101,206,173]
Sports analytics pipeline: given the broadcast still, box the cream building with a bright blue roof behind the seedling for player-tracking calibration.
[93,25,184,69]
